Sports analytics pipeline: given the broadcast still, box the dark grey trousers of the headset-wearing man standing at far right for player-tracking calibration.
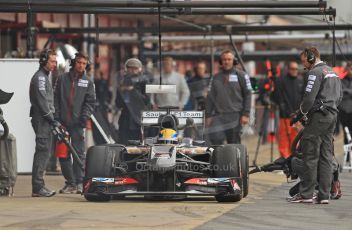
[300,111,337,200]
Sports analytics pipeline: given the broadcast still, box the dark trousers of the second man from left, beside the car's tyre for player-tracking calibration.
[59,127,86,186]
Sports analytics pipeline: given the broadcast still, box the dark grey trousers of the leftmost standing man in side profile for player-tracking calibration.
[31,116,52,193]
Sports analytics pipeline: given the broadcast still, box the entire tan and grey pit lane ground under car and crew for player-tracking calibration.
[0,136,346,229]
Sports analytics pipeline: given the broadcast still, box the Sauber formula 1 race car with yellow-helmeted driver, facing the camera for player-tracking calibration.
[83,107,249,202]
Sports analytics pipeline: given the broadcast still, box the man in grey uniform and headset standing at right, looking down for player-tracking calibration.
[290,47,342,204]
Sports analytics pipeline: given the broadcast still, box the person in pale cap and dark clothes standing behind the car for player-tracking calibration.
[115,58,150,145]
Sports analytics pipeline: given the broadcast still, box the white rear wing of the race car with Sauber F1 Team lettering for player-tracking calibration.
[141,110,204,125]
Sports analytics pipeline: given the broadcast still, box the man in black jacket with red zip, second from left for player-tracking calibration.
[55,53,96,193]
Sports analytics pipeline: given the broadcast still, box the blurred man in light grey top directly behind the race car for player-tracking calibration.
[151,57,190,110]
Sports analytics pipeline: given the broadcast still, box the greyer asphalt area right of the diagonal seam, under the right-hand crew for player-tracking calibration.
[196,169,352,230]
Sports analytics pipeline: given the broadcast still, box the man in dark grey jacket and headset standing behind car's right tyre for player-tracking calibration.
[205,50,252,145]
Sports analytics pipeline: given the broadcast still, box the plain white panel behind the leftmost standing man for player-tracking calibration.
[0,59,39,173]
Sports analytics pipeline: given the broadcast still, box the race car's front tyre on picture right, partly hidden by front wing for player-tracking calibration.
[213,145,242,202]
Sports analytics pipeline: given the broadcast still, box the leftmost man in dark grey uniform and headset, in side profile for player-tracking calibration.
[29,50,60,197]
